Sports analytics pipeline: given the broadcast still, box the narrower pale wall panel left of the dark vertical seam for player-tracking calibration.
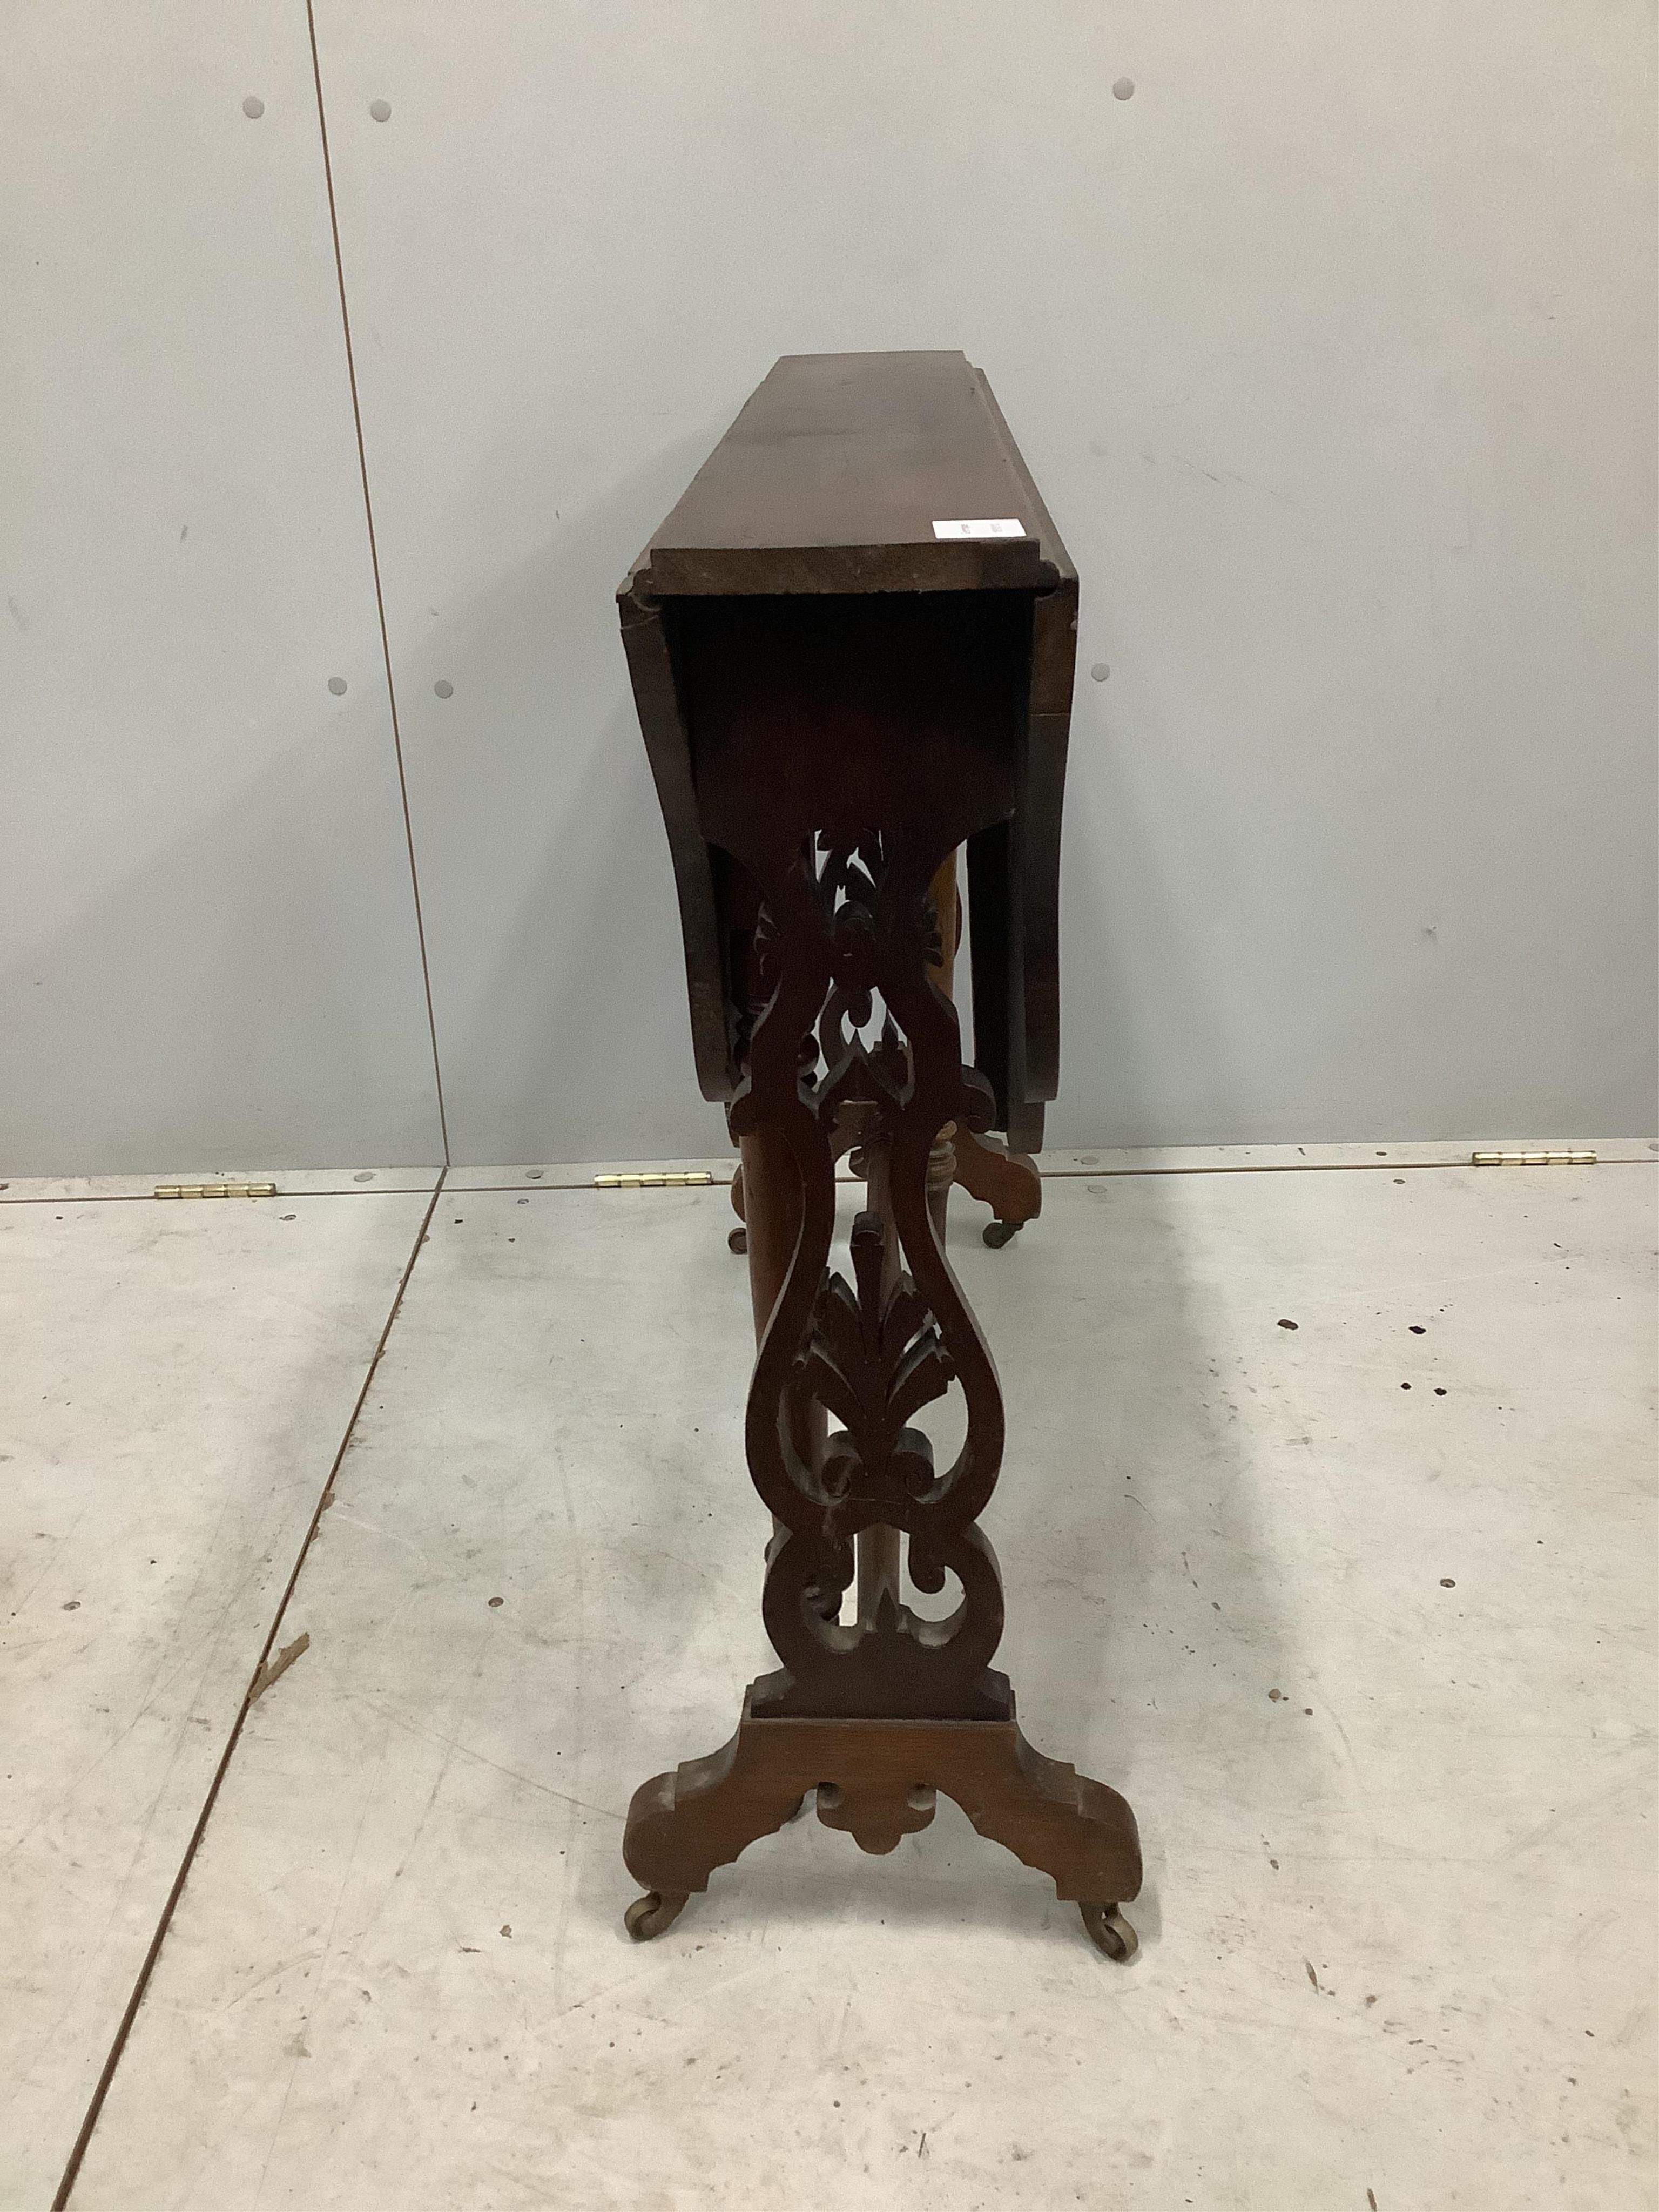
[0,0,442,1172]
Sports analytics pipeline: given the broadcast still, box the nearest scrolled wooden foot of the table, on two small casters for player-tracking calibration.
[622,1703,1142,1960]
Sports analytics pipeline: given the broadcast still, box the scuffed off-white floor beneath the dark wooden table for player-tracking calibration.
[0,1146,1659,2212]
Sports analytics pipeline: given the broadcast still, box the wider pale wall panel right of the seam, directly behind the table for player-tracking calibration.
[319,0,1655,1159]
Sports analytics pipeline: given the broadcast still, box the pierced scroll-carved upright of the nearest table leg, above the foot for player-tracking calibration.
[717,832,1011,1719]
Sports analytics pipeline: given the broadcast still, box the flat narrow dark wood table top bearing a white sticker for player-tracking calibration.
[624,354,1075,597]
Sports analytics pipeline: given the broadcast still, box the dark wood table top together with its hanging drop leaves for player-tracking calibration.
[617,354,1077,1152]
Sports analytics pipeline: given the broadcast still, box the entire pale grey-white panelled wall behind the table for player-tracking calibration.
[0,0,1659,1172]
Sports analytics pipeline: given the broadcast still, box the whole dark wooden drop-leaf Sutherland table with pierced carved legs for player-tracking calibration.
[619,354,1142,1958]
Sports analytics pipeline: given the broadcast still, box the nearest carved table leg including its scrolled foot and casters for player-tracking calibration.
[624,830,1139,1958]
